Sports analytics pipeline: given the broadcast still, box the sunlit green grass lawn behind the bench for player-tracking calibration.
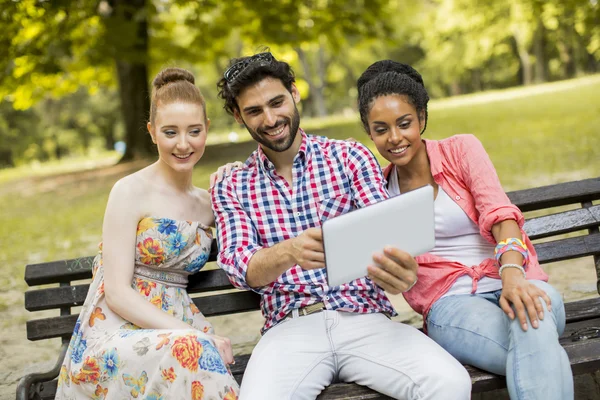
[0,75,600,312]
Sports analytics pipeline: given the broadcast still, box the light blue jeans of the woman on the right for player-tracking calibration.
[427,280,574,400]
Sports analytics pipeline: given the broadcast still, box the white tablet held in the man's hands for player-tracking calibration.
[322,185,435,286]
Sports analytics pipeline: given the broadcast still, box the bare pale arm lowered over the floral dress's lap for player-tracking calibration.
[102,177,191,329]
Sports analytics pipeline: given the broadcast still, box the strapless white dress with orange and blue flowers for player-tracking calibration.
[56,217,239,400]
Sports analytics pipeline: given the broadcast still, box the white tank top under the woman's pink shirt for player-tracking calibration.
[388,169,502,297]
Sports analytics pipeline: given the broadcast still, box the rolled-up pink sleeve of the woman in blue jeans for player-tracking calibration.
[458,135,525,243]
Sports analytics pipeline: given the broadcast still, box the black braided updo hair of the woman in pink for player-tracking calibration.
[356,60,429,134]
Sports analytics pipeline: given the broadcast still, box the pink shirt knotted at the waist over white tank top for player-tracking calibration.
[384,135,548,321]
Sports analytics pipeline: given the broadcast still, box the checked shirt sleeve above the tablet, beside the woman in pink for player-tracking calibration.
[346,142,389,208]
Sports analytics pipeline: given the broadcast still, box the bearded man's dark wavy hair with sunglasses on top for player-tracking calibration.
[217,52,296,115]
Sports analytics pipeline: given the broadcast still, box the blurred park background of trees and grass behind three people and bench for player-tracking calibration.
[0,0,600,398]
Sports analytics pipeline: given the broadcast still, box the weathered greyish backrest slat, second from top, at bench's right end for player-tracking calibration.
[523,205,600,240]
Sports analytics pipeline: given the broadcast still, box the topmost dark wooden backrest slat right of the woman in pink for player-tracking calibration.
[507,177,600,212]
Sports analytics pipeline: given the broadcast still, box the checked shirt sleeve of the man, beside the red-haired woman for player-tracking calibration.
[211,173,262,293]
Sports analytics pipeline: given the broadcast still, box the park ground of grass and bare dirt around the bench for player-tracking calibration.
[0,75,600,399]
